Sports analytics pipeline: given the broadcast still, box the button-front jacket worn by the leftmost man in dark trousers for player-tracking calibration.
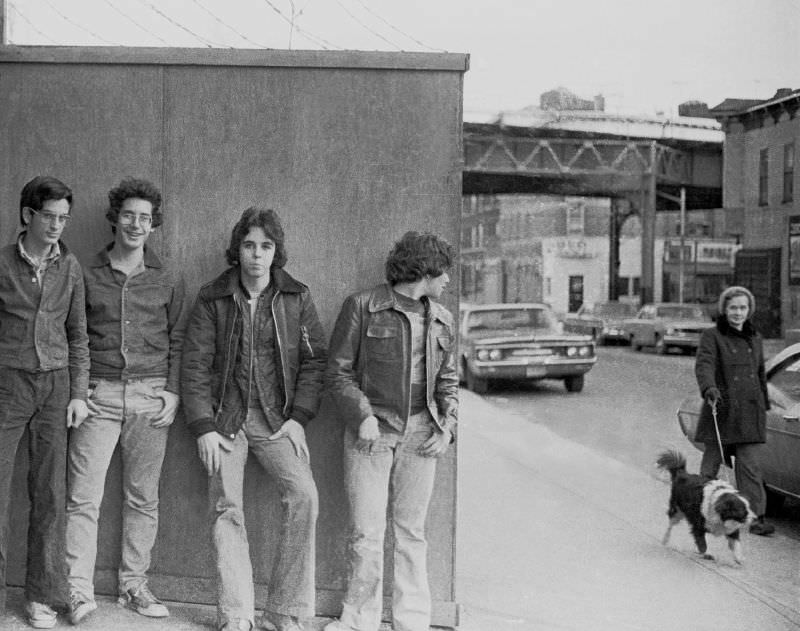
[0,241,89,400]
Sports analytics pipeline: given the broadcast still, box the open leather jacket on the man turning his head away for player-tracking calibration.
[325,284,458,434]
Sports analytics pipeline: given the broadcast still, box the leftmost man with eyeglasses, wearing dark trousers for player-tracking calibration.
[0,176,89,629]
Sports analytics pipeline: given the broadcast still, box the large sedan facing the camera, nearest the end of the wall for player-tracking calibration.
[459,303,597,394]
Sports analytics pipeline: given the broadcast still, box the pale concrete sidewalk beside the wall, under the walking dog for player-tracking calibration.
[456,390,800,631]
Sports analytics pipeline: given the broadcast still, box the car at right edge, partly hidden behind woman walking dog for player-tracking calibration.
[678,344,800,512]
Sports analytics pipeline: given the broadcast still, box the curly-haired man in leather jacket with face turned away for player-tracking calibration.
[326,232,458,631]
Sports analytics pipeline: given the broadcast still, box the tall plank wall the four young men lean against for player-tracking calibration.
[0,47,466,625]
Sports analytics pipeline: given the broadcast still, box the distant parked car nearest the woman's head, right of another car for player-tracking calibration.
[622,302,714,353]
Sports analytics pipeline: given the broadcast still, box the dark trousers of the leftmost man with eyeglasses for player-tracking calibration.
[0,367,69,612]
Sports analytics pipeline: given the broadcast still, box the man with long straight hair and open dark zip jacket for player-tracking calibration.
[181,208,326,631]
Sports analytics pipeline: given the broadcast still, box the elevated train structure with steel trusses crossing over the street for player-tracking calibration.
[463,108,724,303]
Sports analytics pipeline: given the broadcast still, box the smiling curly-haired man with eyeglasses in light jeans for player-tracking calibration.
[66,178,186,624]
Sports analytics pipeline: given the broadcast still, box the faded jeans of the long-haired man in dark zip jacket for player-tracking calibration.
[208,409,319,627]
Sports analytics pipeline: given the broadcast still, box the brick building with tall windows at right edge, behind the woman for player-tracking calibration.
[711,89,800,337]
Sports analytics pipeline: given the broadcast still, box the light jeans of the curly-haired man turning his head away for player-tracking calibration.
[341,411,437,631]
